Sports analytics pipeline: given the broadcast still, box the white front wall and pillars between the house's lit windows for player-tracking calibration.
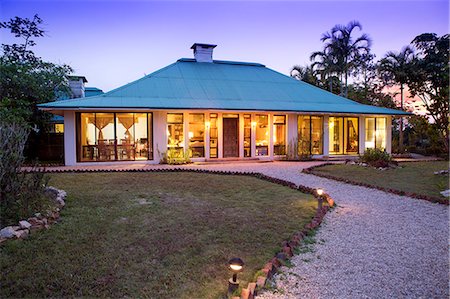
[60,110,398,166]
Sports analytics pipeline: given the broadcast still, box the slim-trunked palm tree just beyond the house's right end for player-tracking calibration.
[379,46,415,152]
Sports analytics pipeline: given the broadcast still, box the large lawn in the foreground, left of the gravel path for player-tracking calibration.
[0,173,316,298]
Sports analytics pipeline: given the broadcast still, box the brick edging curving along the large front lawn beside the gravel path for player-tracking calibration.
[24,163,335,299]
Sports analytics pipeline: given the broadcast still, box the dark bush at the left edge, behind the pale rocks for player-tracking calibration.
[0,121,50,227]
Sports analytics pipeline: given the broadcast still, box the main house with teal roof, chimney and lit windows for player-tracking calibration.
[40,43,409,165]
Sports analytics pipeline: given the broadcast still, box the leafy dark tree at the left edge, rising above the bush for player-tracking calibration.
[0,15,72,159]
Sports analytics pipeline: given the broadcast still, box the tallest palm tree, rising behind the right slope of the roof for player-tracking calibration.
[320,21,372,97]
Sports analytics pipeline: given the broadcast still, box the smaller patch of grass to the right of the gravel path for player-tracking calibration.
[313,161,449,197]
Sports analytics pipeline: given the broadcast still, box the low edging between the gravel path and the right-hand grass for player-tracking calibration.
[302,161,450,206]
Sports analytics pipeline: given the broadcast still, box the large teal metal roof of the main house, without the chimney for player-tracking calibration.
[39,58,409,115]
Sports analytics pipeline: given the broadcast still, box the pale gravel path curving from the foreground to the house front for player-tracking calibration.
[44,162,449,299]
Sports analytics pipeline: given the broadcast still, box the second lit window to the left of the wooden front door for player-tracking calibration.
[189,113,205,158]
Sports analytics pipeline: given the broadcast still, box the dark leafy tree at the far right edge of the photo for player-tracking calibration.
[408,33,450,153]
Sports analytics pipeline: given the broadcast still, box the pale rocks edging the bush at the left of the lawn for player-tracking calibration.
[0,186,67,245]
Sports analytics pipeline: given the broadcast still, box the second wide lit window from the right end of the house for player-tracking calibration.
[328,117,359,155]
